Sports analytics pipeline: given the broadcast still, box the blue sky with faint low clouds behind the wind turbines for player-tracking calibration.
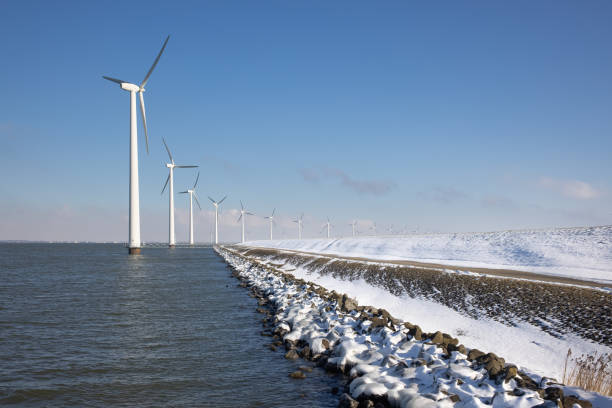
[0,1,612,241]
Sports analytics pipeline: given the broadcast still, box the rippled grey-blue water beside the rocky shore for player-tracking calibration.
[0,244,338,407]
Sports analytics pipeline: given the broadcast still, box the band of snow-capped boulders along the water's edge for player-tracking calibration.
[216,247,605,407]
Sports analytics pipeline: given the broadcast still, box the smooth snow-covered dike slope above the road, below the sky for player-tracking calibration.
[245,226,612,284]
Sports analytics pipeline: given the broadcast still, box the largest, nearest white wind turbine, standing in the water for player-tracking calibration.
[102,36,170,254]
